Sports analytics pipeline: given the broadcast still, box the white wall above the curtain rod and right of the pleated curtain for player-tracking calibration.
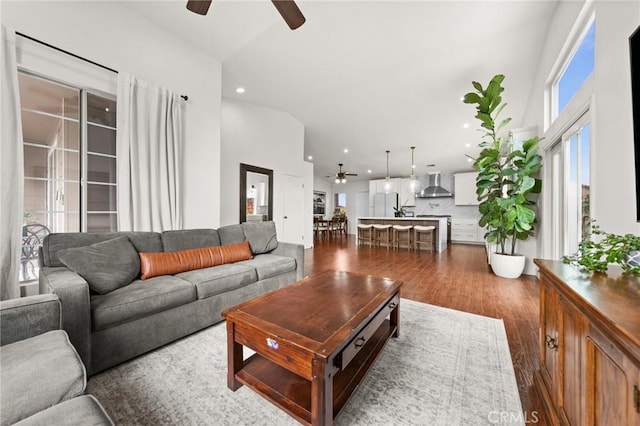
[0,1,222,228]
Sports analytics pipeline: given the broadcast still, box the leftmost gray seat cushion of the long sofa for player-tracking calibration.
[91,275,196,331]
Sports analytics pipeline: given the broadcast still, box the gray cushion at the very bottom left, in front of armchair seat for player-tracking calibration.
[15,395,114,426]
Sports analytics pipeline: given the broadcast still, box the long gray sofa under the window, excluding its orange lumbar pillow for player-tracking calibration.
[39,222,304,375]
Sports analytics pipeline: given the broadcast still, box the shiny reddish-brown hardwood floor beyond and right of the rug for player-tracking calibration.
[304,235,547,425]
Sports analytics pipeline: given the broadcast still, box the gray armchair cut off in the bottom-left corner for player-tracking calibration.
[0,294,113,426]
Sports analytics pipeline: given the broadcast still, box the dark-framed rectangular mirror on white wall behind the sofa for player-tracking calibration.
[240,163,273,223]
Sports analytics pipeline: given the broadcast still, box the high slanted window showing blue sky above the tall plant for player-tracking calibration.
[553,20,596,119]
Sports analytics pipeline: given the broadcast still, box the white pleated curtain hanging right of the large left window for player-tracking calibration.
[117,73,183,232]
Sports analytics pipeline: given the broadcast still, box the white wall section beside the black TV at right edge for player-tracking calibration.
[592,1,640,234]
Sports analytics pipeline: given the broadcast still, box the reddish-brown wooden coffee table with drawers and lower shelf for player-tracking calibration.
[222,271,402,425]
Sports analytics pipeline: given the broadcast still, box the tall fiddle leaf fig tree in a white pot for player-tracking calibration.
[464,74,542,278]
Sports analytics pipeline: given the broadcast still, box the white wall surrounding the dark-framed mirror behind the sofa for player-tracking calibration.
[220,99,313,248]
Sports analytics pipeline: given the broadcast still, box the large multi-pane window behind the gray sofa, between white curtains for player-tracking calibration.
[18,72,117,281]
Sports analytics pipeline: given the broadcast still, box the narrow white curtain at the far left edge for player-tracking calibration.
[0,25,24,300]
